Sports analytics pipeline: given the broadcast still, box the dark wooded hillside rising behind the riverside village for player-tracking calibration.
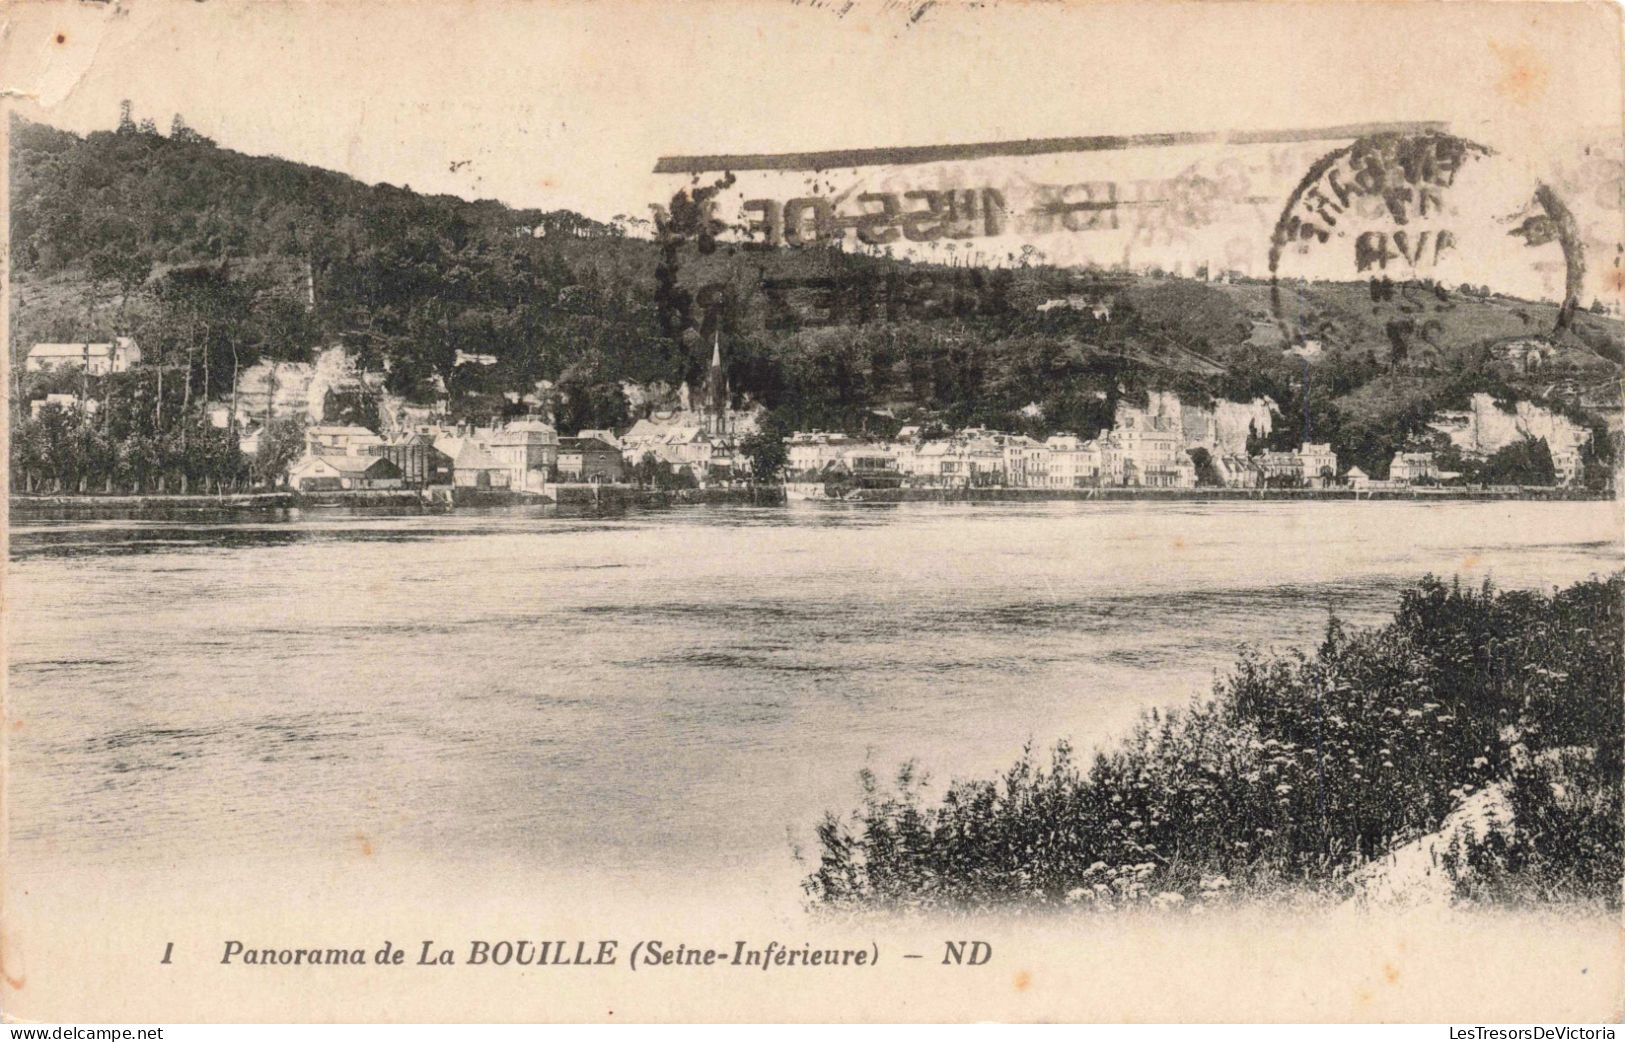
[11,120,1625,467]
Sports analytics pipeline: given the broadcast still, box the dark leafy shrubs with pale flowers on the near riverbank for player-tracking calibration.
[804,575,1625,909]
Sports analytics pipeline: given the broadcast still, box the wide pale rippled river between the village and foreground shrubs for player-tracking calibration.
[7,502,1620,886]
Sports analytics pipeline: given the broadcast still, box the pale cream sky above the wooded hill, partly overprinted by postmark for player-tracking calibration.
[0,0,1622,300]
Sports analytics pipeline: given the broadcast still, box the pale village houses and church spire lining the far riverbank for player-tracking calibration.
[26,336,1591,494]
